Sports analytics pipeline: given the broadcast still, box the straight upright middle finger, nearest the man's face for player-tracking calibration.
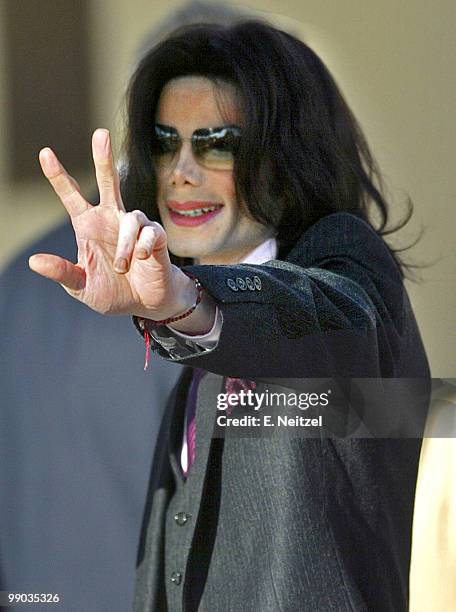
[92,128,125,212]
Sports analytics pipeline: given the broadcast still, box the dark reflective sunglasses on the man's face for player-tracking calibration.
[152,123,241,170]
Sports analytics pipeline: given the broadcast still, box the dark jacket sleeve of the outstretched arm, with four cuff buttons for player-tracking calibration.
[134,213,404,378]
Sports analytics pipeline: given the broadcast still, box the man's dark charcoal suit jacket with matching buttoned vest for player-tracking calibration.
[135,213,429,612]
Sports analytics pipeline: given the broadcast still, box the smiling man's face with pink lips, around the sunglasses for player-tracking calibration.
[155,76,273,264]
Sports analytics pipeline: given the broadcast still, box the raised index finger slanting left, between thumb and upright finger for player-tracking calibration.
[39,147,91,217]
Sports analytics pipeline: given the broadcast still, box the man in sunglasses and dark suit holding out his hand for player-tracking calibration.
[30,22,429,612]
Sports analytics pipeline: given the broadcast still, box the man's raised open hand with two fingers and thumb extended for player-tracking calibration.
[29,129,200,320]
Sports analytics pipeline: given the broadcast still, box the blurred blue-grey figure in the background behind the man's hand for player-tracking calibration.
[0,2,246,612]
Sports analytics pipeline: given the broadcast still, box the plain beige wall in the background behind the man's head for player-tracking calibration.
[0,0,456,377]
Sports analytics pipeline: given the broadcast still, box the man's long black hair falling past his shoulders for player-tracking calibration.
[122,19,412,274]
